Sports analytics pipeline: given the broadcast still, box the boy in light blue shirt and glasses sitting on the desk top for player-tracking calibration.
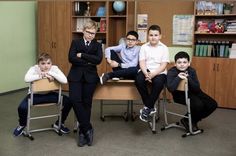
[100,31,140,84]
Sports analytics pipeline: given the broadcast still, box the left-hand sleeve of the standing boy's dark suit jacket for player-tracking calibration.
[68,40,87,65]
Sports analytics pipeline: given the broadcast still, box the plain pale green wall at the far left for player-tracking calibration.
[0,1,37,94]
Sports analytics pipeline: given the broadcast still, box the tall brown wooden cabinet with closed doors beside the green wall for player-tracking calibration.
[38,0,71,78]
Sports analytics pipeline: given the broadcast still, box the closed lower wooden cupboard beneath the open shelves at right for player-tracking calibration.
[192,57,236,108]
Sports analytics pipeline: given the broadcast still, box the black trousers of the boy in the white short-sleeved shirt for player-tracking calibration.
[135,71,166,108]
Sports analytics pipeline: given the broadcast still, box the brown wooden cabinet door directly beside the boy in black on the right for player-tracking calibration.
[191,57,216,98]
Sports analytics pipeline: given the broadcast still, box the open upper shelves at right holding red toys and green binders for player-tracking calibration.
[193,0,236,58]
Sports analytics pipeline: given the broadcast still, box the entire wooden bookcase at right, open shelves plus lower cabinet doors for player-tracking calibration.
[191,0,236,109]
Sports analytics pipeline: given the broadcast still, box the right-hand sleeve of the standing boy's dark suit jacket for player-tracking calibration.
[81,43,103,65]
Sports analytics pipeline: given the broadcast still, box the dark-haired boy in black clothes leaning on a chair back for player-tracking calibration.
[167,51,217,131]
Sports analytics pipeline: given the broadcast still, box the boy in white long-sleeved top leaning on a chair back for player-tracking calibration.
[13,53,72,136]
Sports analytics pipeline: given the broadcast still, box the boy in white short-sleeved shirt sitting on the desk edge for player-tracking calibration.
[135,25,169,122]
